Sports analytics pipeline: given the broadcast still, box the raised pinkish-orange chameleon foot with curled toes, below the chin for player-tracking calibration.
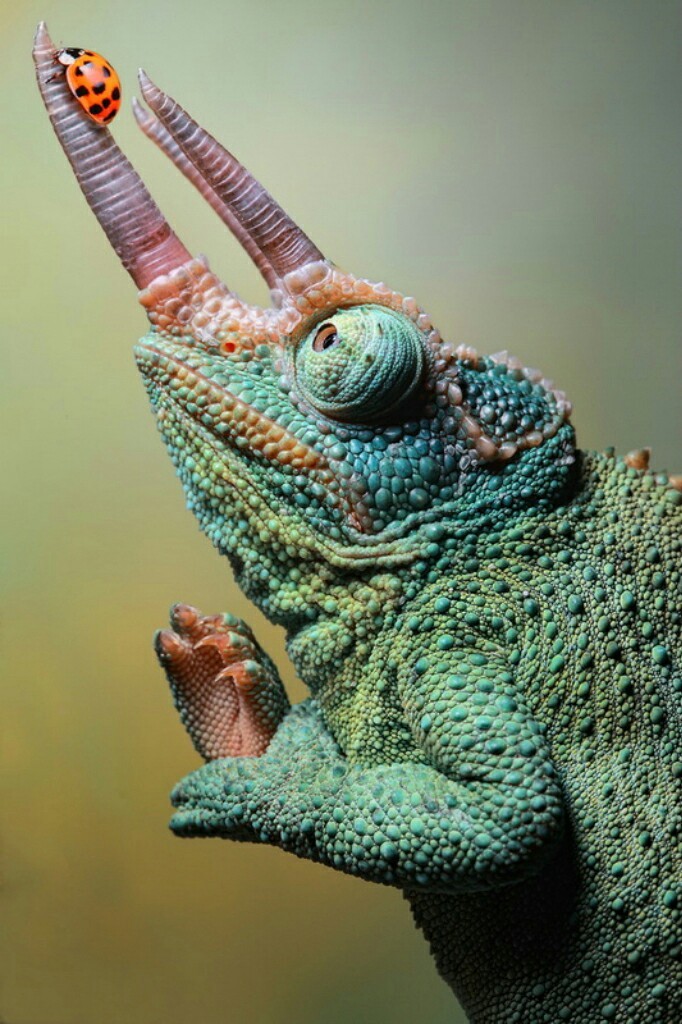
[155,604,289,761]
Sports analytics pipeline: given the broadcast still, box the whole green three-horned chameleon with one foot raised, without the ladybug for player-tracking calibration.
[34,26,682,1024]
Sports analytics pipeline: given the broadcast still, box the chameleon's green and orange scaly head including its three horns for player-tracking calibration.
[34,25,572,617]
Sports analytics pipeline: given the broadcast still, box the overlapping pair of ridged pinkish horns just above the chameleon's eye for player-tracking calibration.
[139,71,325,279]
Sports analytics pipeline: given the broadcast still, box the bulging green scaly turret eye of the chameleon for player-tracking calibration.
[296,306,425,423]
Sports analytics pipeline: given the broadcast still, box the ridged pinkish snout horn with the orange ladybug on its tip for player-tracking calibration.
[33,22,191,289]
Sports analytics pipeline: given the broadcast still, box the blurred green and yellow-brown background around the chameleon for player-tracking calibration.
[0,0,682,1024]
